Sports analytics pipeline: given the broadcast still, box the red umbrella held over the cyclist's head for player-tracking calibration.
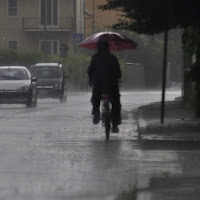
[79,32,137,51]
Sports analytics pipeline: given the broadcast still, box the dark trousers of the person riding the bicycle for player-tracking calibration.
[91,85,121,125]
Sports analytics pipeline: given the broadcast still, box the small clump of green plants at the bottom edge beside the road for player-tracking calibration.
[114,187,137,200]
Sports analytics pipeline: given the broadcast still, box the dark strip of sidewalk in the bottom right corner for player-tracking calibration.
[138,176,200,200]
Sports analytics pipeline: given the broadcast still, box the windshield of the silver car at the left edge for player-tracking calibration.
[0,68,28,80]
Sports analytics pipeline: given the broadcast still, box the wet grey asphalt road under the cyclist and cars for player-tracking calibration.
[0,91,200,200]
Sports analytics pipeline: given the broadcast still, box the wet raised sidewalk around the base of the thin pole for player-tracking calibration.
[136,100,200,142]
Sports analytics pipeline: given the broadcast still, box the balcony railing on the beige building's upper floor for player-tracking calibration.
[23,17,73,31]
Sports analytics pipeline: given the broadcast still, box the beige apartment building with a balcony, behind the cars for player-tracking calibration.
[0,0,84,55]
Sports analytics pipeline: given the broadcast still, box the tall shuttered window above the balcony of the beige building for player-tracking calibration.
[40,0,58,26]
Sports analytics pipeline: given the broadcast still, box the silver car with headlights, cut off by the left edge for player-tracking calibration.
[0,66,37,107]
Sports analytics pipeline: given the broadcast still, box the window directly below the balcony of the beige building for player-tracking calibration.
[40,40,58,55]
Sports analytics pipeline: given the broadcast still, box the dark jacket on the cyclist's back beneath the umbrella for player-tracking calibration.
[88,52,121,88]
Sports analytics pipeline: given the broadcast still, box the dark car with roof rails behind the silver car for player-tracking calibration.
[31,63,68,102]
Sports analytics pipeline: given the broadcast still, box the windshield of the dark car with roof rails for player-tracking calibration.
[31,66,61,79]
